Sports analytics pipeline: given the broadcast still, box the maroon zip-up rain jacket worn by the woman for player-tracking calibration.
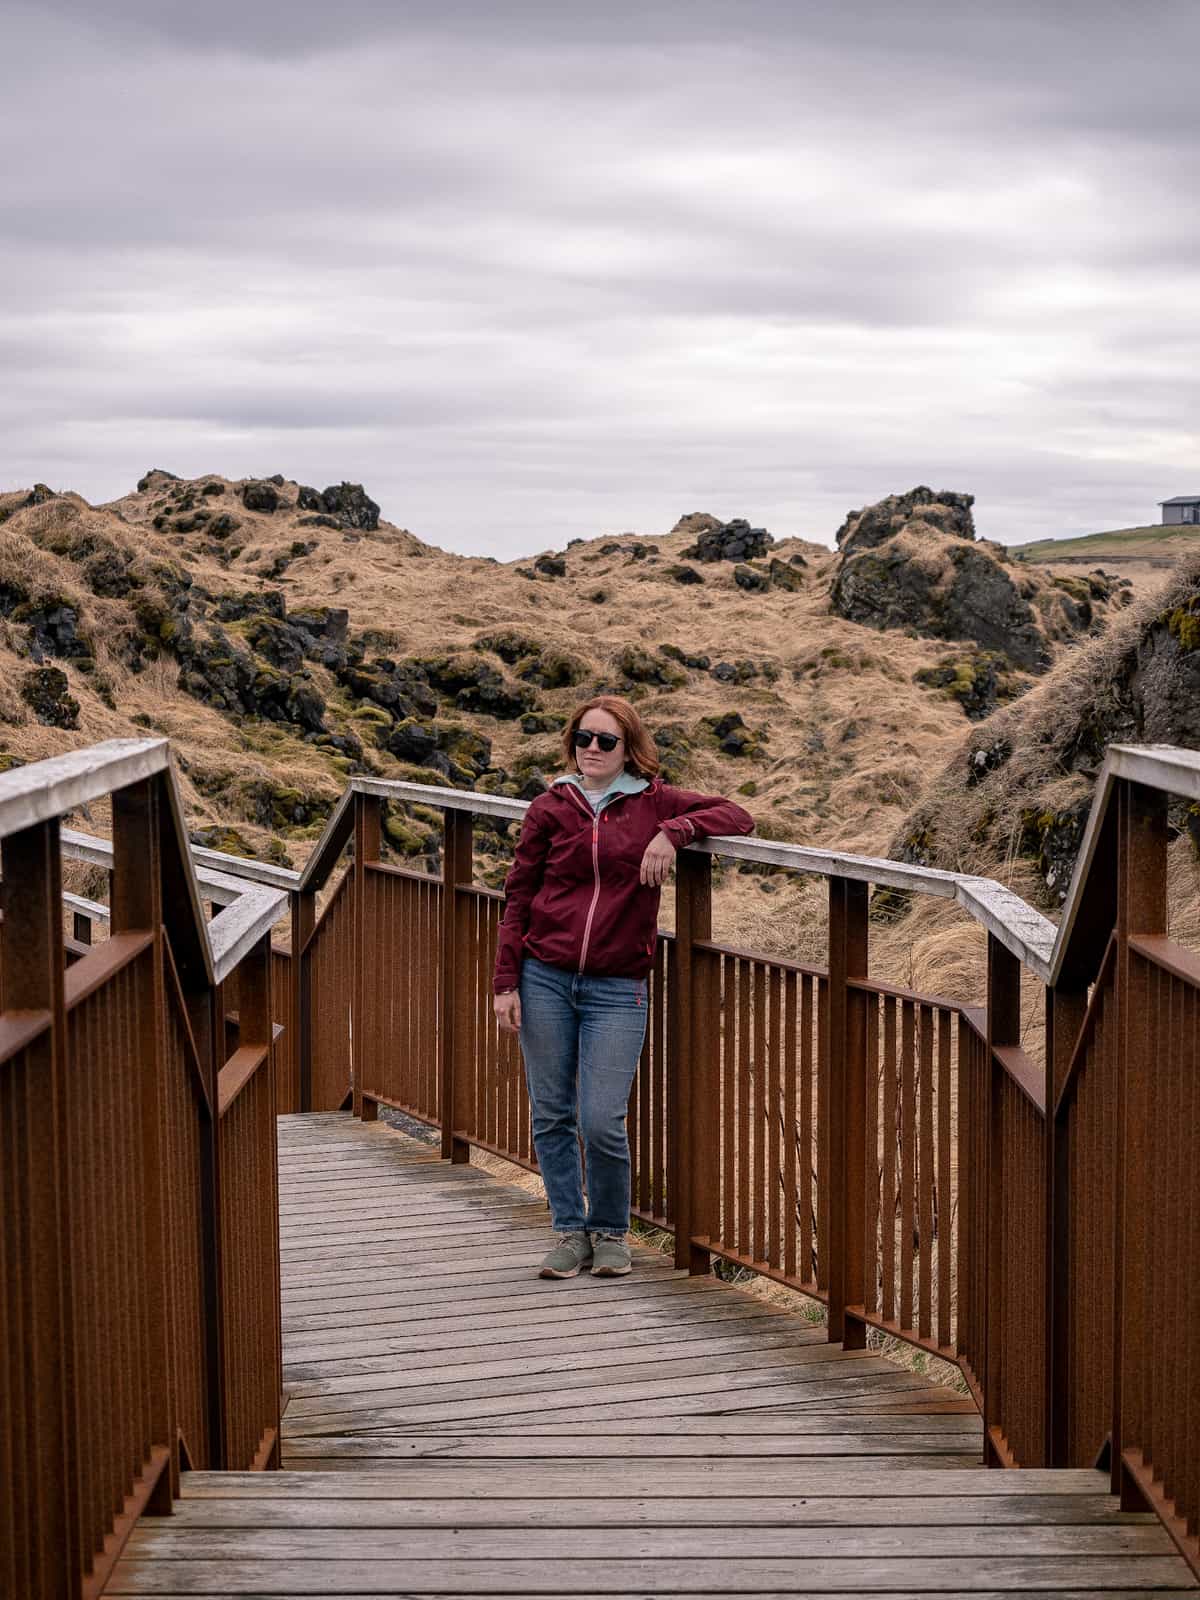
[493,778,754,994]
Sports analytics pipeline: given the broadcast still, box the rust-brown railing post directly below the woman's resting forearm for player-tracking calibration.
[667,850,720,1274]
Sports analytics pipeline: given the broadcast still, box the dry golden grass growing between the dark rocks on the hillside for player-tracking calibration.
[0,475,1195,998]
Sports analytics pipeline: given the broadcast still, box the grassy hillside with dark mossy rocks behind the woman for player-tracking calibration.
[0,472,1177,989]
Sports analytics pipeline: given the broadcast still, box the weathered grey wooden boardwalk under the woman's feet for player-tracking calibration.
[107,1115,1192,1600]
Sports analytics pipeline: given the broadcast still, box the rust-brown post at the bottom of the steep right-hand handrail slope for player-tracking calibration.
[1043,987,1088,1467]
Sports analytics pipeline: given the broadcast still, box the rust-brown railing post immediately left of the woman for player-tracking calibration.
[438,808,475,1166]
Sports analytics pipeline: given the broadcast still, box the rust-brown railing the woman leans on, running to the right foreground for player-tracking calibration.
[320,749,1200,1571]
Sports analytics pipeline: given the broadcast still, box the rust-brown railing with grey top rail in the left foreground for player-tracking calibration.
[0,741,286,1600]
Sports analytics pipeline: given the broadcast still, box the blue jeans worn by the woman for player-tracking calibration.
[520,955,646,1234]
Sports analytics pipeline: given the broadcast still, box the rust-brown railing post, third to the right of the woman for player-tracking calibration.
[979,931,1021,1467]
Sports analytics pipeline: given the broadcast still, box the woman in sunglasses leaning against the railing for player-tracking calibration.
[493,694,754,1278]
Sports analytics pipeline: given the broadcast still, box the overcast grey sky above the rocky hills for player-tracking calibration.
[0,0,1200,558]
